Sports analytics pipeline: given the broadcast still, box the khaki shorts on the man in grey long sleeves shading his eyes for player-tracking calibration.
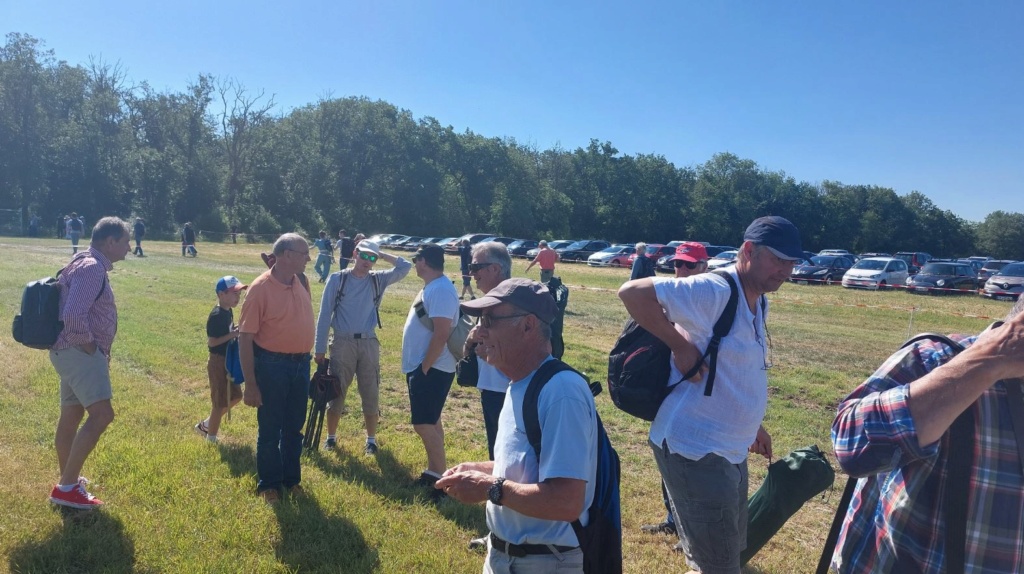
[328,336,381,415]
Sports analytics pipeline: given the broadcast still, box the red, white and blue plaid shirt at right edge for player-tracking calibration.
[831,336,1024,574]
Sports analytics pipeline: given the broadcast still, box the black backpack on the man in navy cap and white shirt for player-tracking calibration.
[608,270,767,421]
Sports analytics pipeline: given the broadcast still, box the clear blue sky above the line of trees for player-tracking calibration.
[0,0,1024,221]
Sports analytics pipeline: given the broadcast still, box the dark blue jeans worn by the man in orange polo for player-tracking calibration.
[256,353,309,492]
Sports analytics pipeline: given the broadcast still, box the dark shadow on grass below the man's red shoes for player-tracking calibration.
[8,506,139,573]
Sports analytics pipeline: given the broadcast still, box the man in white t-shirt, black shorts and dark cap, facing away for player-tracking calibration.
[401,245,459,501]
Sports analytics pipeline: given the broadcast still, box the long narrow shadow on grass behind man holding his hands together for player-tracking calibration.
[307,449,487,535]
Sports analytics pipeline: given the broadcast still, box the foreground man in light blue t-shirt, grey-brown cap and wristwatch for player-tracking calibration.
[434,278,597,573]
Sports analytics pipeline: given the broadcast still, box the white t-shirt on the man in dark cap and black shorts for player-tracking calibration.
[401,275,459,372]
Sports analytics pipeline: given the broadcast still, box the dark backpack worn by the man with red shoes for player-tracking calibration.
[10,252,106,349]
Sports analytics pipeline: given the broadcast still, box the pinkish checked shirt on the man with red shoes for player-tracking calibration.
[53,247,118,357]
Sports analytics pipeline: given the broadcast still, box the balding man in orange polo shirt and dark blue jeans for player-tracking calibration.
[239,233,314,504]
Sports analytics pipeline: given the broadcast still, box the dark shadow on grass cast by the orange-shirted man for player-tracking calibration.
[273,487,379,574]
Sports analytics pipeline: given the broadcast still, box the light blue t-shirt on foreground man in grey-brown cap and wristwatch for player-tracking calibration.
[486,356,597,546]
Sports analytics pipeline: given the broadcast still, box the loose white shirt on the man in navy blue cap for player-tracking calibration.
[650,269,768,465]
